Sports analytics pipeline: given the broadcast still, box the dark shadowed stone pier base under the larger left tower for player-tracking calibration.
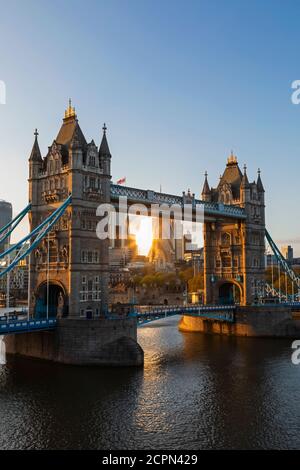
[5,318,144,366]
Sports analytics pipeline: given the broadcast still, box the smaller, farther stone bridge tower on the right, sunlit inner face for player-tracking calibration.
[202,154,265,305]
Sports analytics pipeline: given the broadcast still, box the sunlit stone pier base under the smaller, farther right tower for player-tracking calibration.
[179,305,300,339]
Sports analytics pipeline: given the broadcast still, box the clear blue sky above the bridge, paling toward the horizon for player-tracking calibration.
[0,0,300,255]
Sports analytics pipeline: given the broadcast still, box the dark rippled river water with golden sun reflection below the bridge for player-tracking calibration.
[0,318,300,449]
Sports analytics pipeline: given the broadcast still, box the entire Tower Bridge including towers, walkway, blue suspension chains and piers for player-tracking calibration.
[0,103,300,365]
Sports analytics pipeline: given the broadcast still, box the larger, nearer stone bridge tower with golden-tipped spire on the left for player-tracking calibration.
[29,102,111,318]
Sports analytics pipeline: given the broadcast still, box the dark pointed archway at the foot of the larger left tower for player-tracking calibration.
[34,281,68,318]
